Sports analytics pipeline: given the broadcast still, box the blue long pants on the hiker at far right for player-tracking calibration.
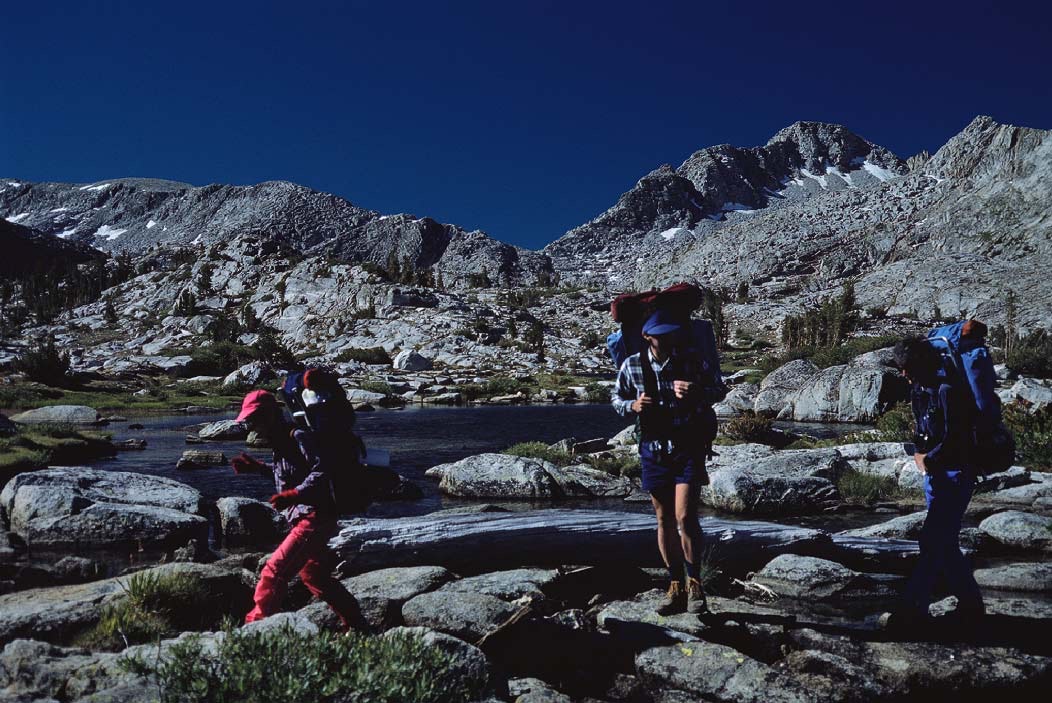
[905,471,983,615]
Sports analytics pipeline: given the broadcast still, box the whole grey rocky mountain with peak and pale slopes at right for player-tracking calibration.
[544,117,1052,332]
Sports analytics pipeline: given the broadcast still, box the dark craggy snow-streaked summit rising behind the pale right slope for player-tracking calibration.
[544,122,906,286]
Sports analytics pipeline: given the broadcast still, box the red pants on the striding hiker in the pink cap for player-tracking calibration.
[245,514,362,628]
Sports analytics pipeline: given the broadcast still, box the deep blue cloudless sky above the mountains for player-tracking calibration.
[0,0,1052,247]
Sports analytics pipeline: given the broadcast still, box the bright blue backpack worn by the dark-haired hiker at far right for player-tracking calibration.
[928,320,1015,475]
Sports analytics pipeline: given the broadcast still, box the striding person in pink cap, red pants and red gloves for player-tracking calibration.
[230,390,368,630]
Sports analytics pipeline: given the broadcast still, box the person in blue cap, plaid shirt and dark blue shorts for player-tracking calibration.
[612,309,726,615]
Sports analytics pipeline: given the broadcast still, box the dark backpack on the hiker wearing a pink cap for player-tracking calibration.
[279,368,373,513]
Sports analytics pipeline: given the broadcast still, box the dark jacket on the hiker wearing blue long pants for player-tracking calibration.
[910,383,975,473]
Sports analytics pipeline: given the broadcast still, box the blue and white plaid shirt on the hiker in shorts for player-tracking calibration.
[611,349,727,449]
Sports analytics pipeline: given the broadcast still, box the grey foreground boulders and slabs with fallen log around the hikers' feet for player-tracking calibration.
[0,406,1052,703]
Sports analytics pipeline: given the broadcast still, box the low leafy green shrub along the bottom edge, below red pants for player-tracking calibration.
[121,626,482,703]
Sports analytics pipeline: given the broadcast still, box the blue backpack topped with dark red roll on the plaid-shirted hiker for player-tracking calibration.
[606,283,726,455]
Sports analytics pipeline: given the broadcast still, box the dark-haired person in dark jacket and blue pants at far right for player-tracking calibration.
[888,338,985,629]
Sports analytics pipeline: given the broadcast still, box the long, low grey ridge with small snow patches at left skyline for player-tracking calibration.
[0,178,551,286]
